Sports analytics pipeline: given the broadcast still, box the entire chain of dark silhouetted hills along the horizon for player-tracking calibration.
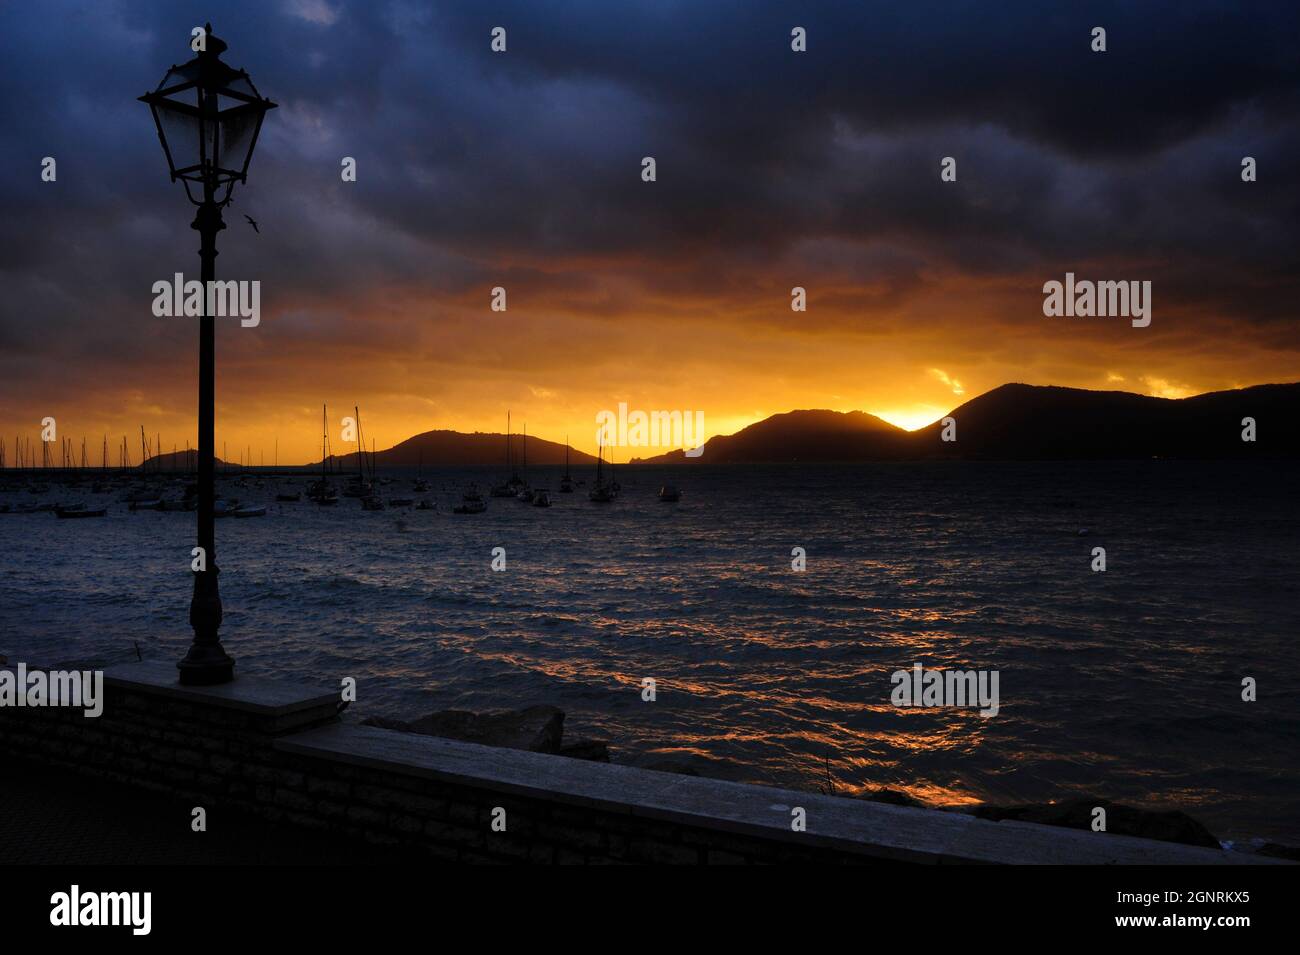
[137,382,1300,473]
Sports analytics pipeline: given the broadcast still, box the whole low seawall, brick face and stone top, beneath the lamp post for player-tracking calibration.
[0,663,1279,864]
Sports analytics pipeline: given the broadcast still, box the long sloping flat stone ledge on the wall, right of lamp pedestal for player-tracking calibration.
[273,724,1282,865]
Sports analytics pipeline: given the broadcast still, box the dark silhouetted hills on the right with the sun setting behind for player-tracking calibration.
[631,383,1300,464]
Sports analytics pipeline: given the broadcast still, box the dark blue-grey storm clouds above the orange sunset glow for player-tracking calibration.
[0,0,1300,413]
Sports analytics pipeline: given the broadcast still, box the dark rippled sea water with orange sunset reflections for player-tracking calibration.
[0,461,1300,845]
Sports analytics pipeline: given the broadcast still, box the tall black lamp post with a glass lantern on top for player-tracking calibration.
[140,23,276,685]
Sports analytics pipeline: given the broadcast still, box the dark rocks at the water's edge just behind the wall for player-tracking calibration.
[361,706,1300,860]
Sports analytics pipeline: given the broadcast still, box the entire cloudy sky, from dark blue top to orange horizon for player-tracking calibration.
[0,0,1300,463]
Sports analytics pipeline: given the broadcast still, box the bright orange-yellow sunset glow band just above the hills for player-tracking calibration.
[5,275,1291,464]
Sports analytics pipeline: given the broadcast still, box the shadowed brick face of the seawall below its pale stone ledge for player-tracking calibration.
[0,681,870,864]
